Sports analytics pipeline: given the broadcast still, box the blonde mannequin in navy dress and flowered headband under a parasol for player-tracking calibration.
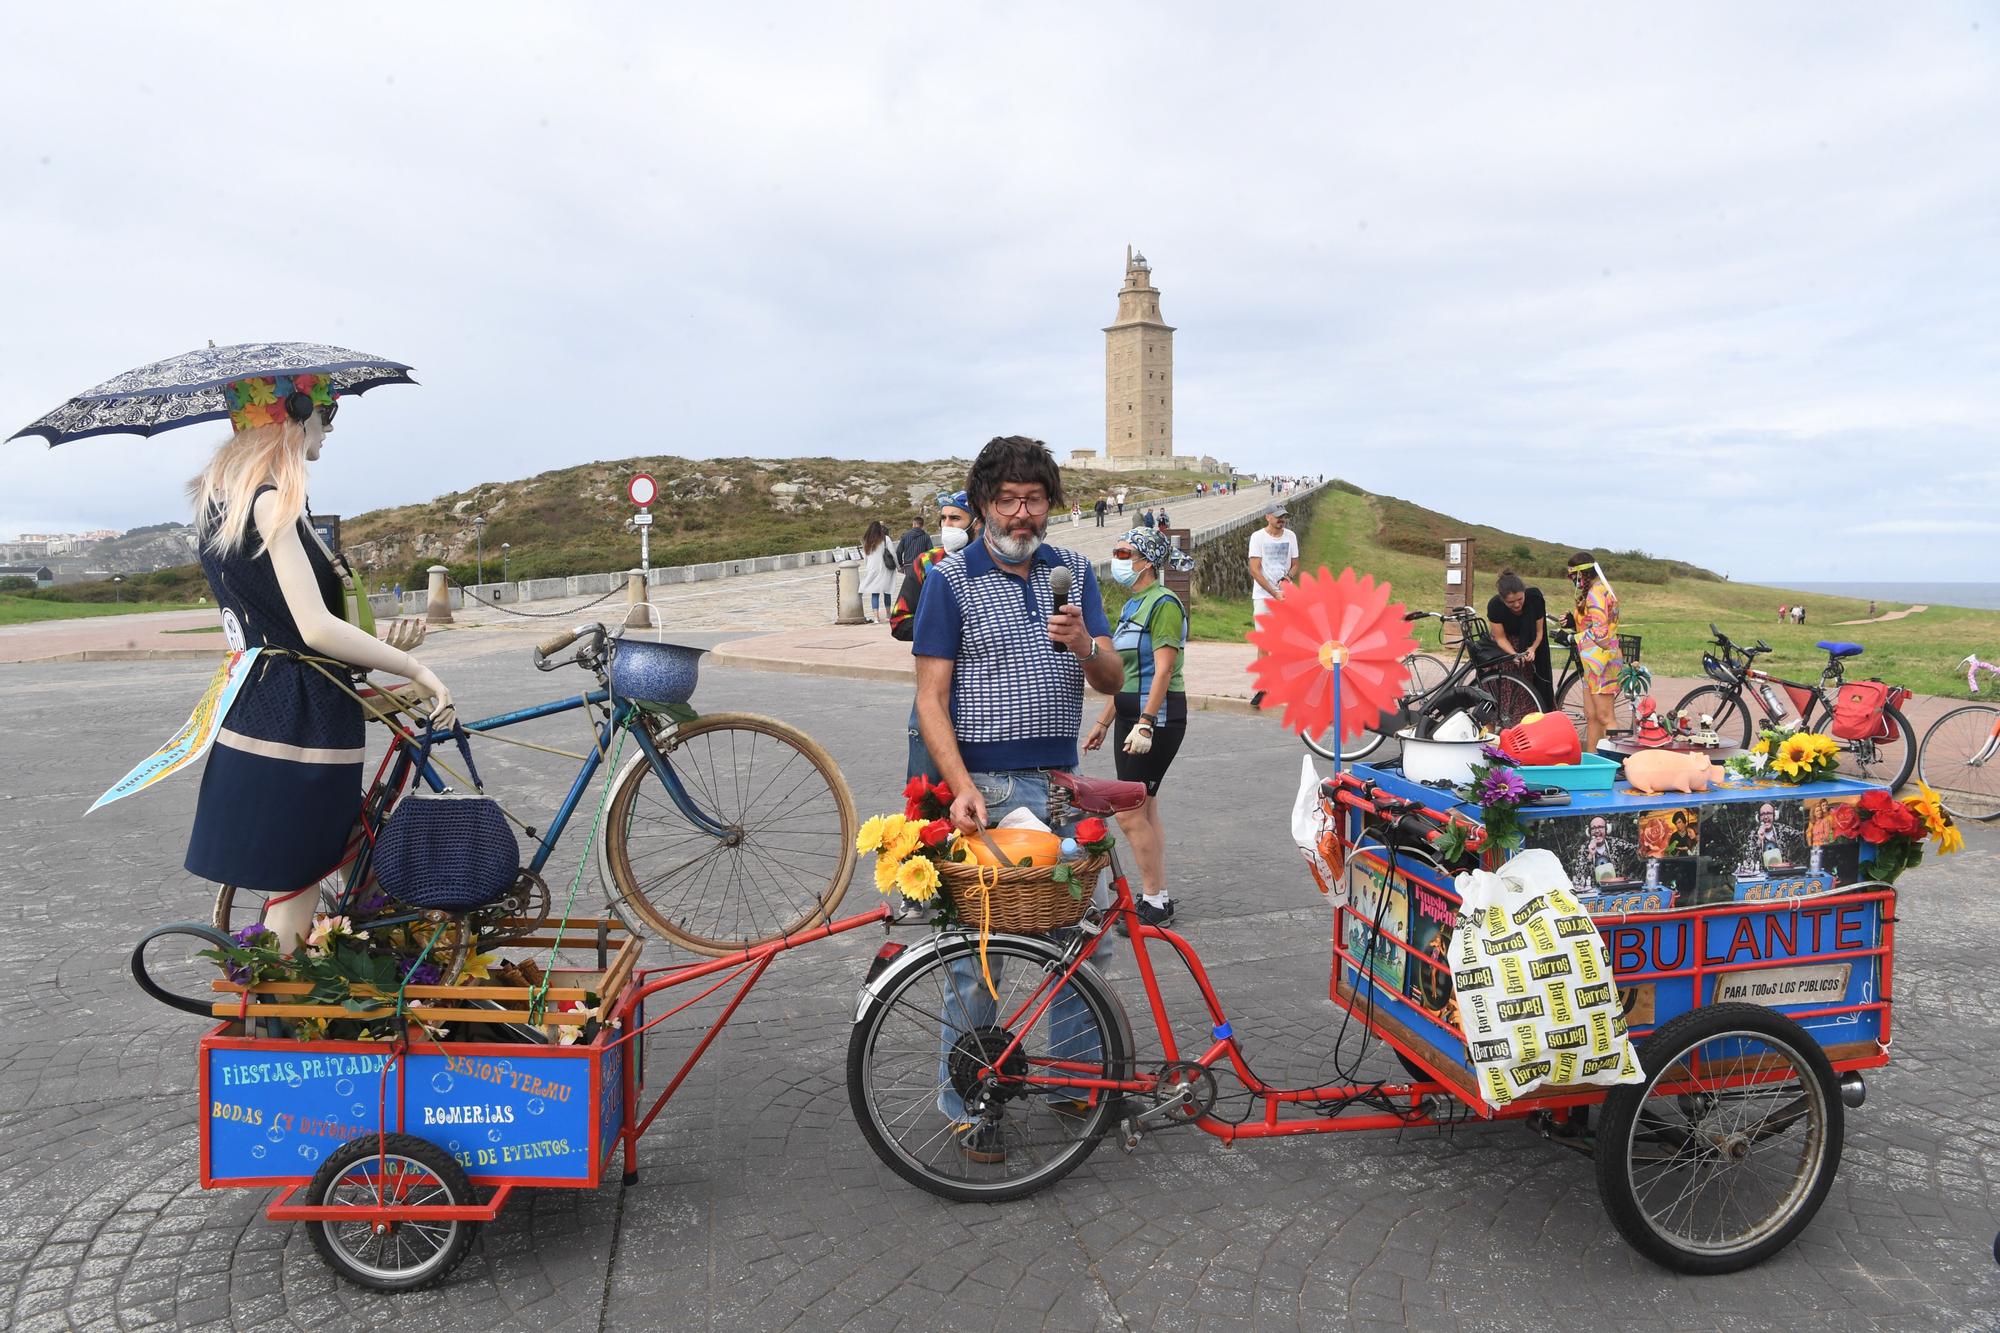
[188,374,452,949]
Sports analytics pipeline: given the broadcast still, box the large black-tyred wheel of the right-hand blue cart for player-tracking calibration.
[1596,1005,1842,1275]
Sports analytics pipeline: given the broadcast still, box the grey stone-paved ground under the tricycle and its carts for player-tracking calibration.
[0,634,2000,1333]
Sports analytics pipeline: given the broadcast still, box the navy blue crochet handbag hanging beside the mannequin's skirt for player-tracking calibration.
[374,725,520,913]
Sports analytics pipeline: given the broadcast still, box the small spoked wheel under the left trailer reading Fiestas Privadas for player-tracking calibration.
[306,1135,478,1291]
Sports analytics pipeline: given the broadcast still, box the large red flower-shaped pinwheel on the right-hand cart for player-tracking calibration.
[1250,564,1416,741]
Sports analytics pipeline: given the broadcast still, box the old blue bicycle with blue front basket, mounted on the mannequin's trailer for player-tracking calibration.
[132,624,856,1015]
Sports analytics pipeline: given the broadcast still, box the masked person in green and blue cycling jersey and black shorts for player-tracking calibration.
[1084,528,1194,929]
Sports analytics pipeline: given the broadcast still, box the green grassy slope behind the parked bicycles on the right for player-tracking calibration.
[1194,486,2000,695]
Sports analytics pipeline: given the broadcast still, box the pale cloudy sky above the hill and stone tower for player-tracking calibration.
[0,2,2000,578]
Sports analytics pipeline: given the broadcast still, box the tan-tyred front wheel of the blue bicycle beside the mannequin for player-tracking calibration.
[598,713,856,957]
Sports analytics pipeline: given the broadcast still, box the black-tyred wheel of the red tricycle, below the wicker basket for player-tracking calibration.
[848,937,1128,1203]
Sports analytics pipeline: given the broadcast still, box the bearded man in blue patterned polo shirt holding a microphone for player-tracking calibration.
[912,434,1124,1163]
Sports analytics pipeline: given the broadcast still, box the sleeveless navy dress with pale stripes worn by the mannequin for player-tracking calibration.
[186,486,366,893]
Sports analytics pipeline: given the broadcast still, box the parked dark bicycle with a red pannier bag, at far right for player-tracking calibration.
[1678,624,1916,791]
